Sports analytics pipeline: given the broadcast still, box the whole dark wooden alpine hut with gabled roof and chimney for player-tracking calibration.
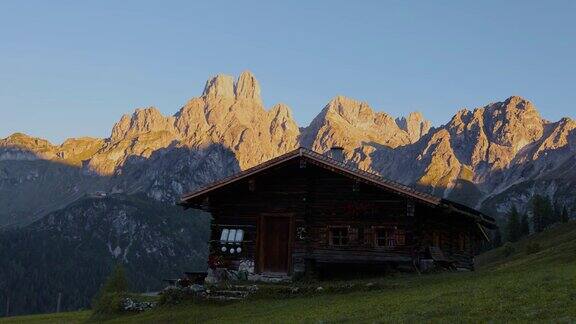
[180,148,495,277]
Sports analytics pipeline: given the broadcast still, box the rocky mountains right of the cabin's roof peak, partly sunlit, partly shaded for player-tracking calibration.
[301,96,576,212]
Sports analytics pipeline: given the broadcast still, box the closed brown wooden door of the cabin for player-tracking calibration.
[259,216,291,273]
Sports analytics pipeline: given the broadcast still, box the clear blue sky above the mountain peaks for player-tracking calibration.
[0,0,576,143]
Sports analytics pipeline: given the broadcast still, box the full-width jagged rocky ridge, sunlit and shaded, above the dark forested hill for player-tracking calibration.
[0,72,576,227]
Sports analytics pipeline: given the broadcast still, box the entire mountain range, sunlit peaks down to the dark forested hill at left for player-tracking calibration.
[0,72,576,313]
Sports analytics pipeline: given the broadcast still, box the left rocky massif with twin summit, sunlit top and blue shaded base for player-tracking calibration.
[0,72,300,227]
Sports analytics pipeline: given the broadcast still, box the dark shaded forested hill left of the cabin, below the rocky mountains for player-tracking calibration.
[0,194,208,314]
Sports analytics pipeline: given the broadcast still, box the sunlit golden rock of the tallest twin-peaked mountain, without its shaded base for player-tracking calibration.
[90,72,299,175]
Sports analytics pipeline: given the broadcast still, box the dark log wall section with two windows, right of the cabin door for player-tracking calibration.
[295,165,414,263]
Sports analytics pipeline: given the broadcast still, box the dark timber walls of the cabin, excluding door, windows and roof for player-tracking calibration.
[200,159,480,273]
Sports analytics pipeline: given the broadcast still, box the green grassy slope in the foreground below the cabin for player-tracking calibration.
[0,222,576,323]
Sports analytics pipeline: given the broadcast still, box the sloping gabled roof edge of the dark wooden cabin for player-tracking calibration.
[178,147,495,228]
